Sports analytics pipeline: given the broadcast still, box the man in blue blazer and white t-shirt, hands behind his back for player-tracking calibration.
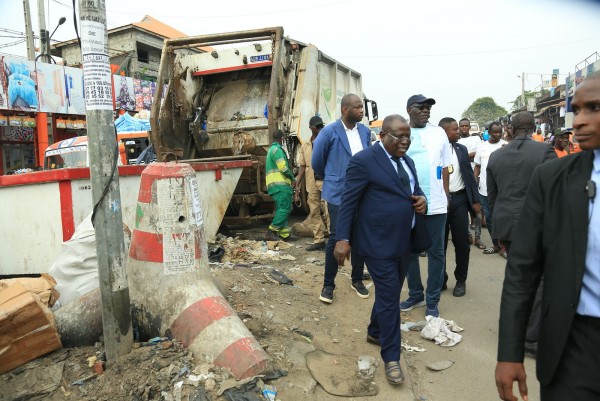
[312,93,371,304]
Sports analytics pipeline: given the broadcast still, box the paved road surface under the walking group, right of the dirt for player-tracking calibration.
[402,231,540,401]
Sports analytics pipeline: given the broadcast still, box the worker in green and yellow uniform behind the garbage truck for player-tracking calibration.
[265,129,296,241]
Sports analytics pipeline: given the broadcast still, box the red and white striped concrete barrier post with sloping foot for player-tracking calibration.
[127,163,270,379]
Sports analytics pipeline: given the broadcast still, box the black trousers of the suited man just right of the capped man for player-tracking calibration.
[444,192,471,283]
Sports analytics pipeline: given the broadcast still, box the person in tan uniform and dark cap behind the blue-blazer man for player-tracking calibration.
[295,116,329,251]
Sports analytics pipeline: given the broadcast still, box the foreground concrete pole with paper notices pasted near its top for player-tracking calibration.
[79,0,133,364]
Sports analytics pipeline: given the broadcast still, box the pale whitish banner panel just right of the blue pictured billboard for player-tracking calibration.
[35,63,67,114]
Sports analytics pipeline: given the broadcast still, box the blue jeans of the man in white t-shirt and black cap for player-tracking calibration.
[406,213,446,305]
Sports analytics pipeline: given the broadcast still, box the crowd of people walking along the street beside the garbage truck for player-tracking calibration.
[267,73,600,394]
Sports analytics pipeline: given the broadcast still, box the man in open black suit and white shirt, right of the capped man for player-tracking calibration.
[438,117,480,297]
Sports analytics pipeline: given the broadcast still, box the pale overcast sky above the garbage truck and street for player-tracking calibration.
[0,0,600,123]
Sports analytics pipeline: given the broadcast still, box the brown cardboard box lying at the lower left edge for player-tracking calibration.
[0,283,62,374]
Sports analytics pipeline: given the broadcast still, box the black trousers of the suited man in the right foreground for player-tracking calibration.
[541,315,600,401]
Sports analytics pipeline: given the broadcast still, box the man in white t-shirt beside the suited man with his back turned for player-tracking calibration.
[475,121,506,254]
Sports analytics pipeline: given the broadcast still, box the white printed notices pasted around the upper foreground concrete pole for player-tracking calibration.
[81,19,112,111]
